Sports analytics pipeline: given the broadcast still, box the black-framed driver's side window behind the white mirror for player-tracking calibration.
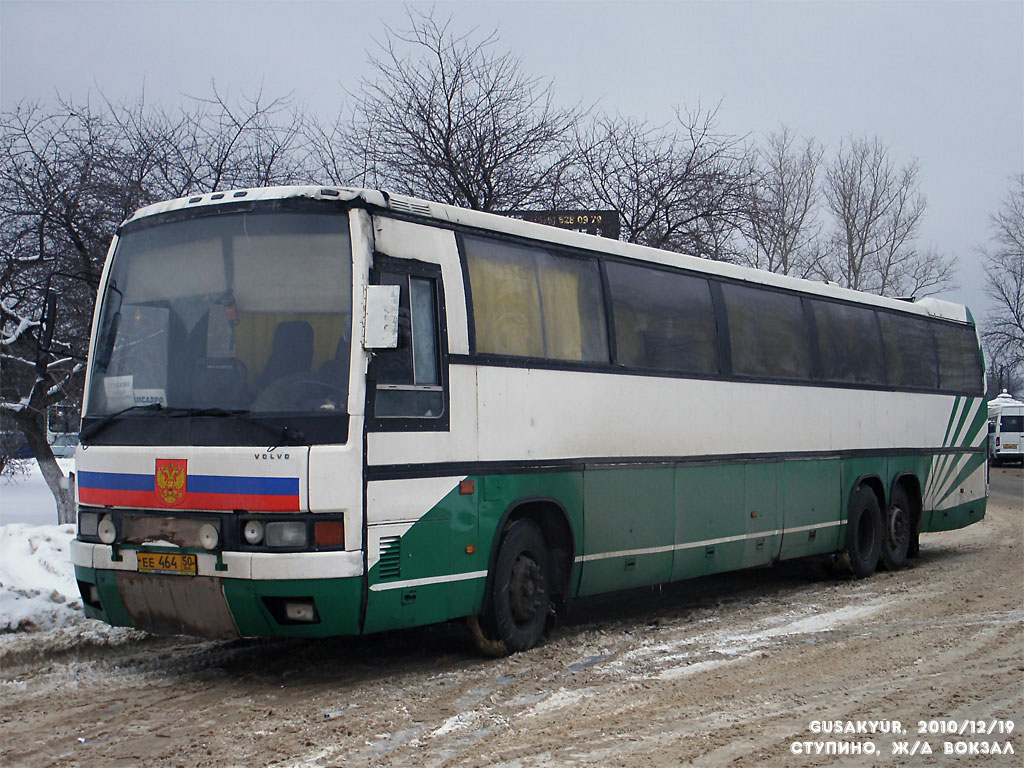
[373,269,445,420]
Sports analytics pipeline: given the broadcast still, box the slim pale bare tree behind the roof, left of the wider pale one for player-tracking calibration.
[740,126,824,278]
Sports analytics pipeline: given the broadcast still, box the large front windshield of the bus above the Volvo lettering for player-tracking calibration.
[86,211,352,418]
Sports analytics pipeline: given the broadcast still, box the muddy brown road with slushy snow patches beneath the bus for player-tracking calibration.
[0,468,1024,768]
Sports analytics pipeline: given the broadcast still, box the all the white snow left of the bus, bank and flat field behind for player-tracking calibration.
[0,459,86,632]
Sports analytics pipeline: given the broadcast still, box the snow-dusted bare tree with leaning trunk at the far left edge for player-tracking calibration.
[0,102,118,522]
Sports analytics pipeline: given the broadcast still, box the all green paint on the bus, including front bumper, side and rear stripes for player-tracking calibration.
[75,443,985,637]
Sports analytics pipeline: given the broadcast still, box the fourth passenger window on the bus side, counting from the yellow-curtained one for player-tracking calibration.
[811,300,886,385]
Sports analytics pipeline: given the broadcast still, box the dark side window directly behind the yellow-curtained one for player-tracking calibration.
[605,262,719,374]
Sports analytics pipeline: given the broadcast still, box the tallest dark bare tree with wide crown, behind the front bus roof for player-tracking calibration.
[331,10,578,211]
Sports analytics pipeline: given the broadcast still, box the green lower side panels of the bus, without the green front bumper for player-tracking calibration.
[364,454,966,632]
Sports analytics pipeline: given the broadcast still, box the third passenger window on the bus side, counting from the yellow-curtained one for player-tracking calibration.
[722,283,811,379]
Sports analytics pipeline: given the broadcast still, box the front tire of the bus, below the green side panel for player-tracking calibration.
[485,518,551,653]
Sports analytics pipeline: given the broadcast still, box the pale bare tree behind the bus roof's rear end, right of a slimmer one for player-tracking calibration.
[818,137,955,296]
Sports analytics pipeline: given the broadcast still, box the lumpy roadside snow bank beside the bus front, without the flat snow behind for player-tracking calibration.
[0,523,84,632]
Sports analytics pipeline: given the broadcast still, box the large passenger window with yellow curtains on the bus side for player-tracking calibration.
[464,237,608,362]
